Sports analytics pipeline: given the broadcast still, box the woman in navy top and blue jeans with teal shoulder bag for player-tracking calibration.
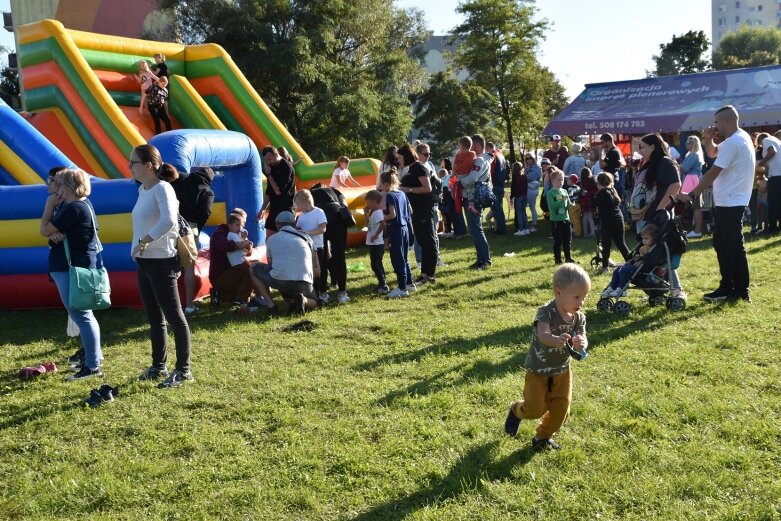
[40,168,103,381]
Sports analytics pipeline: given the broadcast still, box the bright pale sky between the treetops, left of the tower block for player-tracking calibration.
[396,0,711,100]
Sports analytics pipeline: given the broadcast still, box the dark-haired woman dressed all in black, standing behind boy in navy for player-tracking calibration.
[399,143,439,285]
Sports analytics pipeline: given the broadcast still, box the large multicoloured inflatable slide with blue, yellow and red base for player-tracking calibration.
[0,20,378,308]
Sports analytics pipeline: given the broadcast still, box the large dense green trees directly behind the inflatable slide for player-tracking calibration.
[161,0,427,160]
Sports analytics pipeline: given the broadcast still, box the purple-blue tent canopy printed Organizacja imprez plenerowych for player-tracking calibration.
[543,65,781,136]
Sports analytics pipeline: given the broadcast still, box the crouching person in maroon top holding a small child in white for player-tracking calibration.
[209,211,252,304]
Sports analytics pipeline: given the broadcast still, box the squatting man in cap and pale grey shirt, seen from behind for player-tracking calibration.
[250,211,320,313]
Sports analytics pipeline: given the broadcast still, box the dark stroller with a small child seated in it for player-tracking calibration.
[597,201,687,315]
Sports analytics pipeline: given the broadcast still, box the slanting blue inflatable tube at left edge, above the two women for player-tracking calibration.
[0,100,74,185]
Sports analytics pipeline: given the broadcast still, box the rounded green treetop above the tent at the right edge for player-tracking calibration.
[713,25,781,70]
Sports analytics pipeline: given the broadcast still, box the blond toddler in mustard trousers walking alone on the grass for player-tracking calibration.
[504,263,591,450]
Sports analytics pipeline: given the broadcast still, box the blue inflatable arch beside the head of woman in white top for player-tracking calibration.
[150,129,265,244]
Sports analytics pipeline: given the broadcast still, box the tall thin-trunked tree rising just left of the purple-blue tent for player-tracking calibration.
[451,0,564,160]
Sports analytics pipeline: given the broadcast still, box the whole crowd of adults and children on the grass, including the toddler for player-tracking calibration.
[40,102,756,442]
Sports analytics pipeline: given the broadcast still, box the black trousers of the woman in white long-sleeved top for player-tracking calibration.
[136,257,190,371]
